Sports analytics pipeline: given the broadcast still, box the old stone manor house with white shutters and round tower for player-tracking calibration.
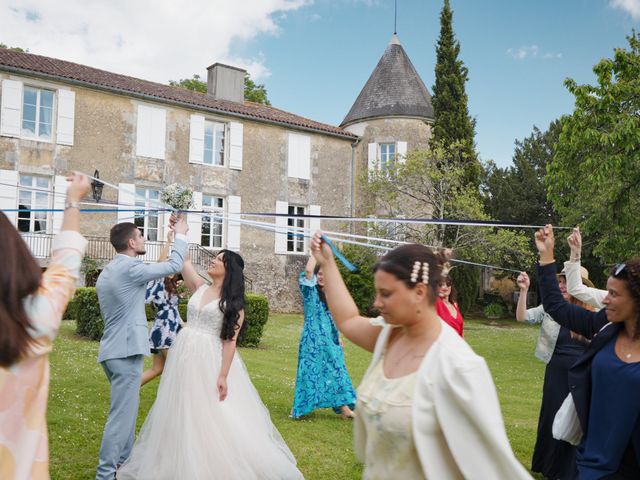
[0,35,433,311]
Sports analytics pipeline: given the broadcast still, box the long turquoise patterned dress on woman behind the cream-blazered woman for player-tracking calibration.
[291,272,356,418]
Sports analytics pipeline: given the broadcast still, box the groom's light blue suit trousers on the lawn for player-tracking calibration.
[96,355,144,480]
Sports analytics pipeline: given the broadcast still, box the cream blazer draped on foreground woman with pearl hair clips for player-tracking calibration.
[353,317,531,480]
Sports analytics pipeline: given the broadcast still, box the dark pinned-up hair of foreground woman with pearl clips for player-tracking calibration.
[373,243,450,304]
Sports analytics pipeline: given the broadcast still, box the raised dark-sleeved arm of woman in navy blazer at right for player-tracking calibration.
[536,225,607,338]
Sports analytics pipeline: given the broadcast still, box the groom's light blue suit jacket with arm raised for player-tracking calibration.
[96,236,188,362]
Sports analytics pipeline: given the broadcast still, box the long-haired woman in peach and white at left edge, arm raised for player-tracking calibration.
[0,175,90,480]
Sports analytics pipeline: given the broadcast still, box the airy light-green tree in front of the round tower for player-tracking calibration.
[361,144,533,274]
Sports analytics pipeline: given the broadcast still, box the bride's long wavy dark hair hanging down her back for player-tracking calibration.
[218,250,247,340]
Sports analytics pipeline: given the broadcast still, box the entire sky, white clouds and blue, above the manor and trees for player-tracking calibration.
[0,0,640,166]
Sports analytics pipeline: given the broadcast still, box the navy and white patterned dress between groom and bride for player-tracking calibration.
[146,279,182,350]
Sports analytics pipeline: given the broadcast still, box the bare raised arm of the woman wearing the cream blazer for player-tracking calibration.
[311,232,382,352]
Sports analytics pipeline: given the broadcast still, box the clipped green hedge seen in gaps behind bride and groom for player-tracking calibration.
[74,287,269,347]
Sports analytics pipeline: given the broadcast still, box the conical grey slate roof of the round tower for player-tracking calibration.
[340,34,433,127]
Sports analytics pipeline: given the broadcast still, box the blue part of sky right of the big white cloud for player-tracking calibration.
[246,0,638,165]
